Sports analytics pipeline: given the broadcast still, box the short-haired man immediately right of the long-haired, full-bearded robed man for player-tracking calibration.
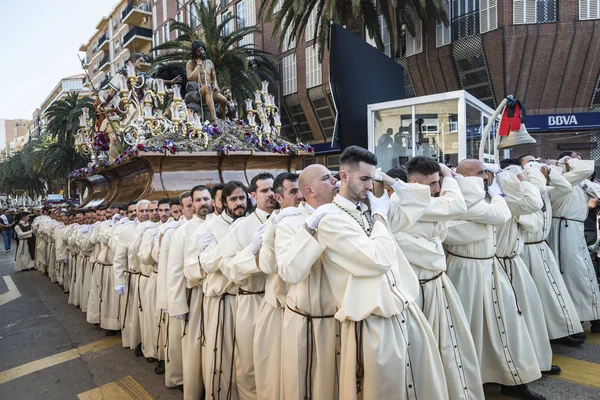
[219,172,277,399]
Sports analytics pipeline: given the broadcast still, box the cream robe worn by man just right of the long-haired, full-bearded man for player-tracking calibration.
[219,209,269,400]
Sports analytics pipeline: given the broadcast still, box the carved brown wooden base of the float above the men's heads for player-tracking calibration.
[75,152,313,208]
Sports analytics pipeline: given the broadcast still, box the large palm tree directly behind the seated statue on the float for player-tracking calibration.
[153,2,279,104]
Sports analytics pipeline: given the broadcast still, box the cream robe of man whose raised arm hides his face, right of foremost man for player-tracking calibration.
[393,178,484,400]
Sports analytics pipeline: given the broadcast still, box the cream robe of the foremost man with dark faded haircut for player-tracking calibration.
[317,192,448,399]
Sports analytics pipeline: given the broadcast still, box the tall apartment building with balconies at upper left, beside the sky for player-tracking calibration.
[79,0,152,89]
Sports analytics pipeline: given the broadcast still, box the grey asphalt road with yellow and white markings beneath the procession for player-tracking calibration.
[0,239,600,400]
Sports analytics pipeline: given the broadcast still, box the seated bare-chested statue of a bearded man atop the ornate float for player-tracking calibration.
[185,40,227,121]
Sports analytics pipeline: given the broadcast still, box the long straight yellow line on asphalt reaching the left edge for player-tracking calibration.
[0,336,121,385]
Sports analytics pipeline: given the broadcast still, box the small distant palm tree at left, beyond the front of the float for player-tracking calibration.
[45,92,95,147]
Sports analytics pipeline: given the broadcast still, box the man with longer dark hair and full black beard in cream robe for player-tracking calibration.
[193,181,248,400]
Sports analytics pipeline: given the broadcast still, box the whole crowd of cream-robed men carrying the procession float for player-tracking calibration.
[19,146,600,400]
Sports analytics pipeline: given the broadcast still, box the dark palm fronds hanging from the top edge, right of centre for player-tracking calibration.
[258,0,448,62]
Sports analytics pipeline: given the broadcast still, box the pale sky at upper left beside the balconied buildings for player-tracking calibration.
[0,0,116,119]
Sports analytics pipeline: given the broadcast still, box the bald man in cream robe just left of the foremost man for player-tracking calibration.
[270,164,340,400]
